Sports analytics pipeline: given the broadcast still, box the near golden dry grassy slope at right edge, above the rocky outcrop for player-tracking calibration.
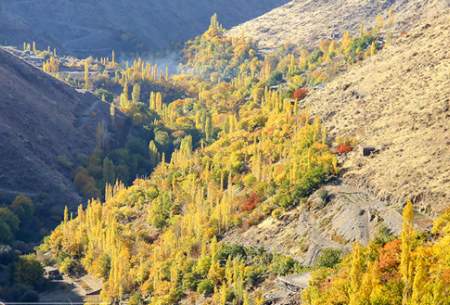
[305,10,450,213]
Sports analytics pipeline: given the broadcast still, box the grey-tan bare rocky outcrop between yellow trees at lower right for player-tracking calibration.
[225,182,408,266]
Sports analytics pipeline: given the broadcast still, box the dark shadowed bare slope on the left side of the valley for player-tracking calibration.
[0,49,121,221]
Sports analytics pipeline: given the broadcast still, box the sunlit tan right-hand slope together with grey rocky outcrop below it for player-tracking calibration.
[225,1,450,263]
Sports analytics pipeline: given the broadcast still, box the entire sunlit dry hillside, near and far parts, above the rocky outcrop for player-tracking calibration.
[228,0,450,213]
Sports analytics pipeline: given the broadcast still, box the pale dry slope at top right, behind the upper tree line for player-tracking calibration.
[229,0,449,49]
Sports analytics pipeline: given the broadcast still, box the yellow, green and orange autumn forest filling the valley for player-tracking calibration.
[0,10,450,305]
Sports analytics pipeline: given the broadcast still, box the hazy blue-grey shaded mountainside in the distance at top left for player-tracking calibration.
[0,0,287,56]
